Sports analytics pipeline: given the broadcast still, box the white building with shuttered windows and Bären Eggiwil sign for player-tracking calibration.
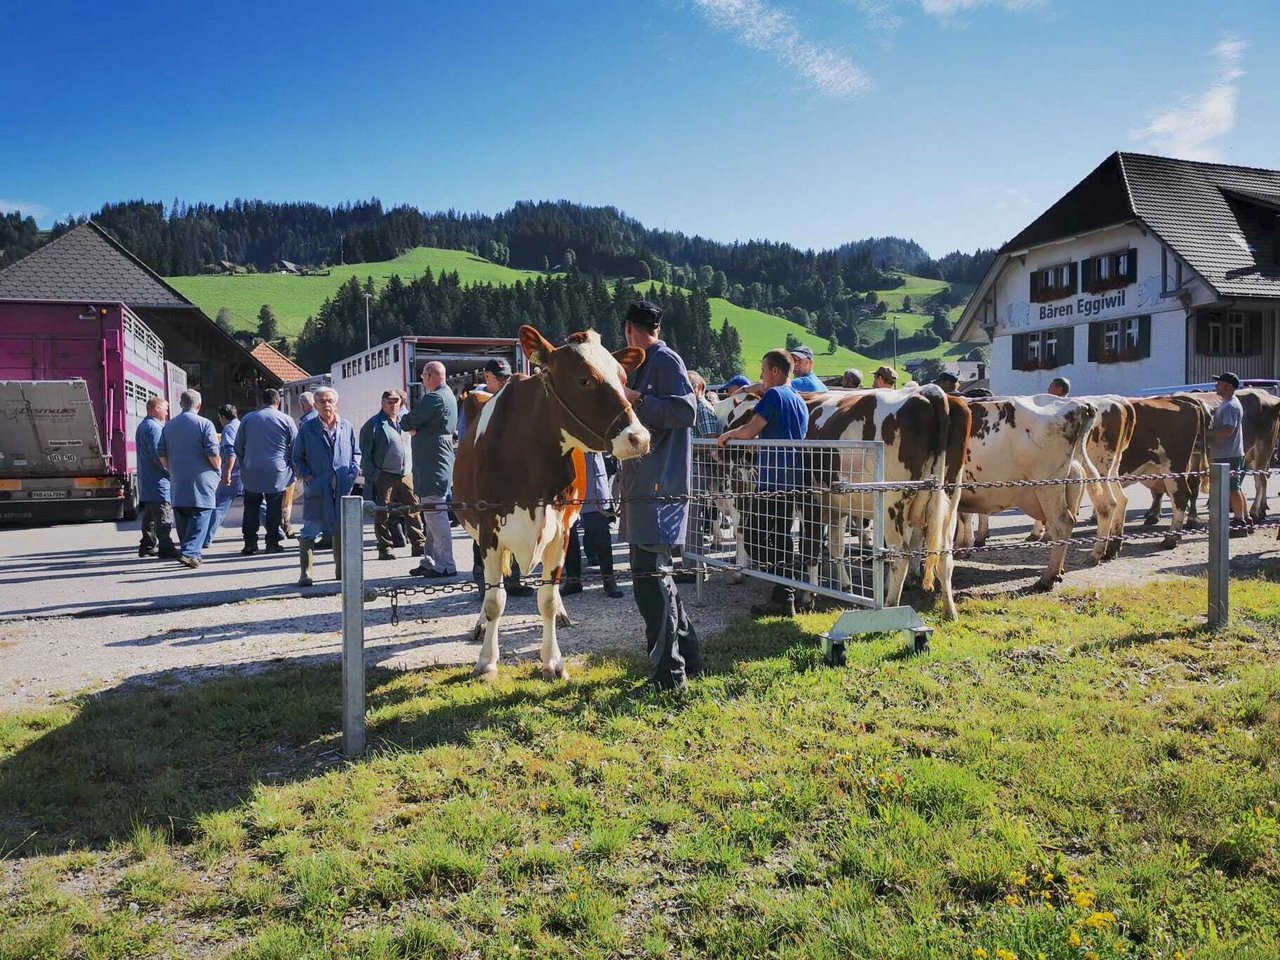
[951,152,1280,394]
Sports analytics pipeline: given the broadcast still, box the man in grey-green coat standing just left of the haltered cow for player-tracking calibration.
[401,360,458,577]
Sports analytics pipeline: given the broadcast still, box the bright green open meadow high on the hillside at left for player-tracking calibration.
[165,247,555,337]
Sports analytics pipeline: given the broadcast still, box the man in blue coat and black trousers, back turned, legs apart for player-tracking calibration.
[236,388,298,557]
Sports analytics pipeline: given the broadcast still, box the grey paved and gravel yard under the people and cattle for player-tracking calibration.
[0,503,1280,709]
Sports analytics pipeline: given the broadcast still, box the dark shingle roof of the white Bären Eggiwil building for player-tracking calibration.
[1000,152,1280,297]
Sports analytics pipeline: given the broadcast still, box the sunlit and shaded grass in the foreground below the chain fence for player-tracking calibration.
[0,580,1280,960]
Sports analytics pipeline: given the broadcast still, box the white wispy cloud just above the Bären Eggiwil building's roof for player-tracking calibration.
[1133,37,1248,160]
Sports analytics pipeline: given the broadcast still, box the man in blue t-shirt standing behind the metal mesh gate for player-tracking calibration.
[717,349,809,617]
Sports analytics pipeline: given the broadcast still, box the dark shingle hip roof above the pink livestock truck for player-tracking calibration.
[0,220,195,308]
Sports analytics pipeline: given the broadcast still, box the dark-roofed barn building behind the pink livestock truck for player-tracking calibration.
[0,220,282,415]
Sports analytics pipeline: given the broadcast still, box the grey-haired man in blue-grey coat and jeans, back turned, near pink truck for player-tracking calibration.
[156,390,223,570]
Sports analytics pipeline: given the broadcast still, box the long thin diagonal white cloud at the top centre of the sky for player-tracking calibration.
[694,0,870,97]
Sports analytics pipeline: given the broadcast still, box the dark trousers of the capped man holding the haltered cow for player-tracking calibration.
[631,544,703,689]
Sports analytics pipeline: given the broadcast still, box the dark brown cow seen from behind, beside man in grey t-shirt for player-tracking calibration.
[1120,393,1208,547]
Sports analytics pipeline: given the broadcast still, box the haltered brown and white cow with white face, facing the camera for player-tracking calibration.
[453,326,649,680]
